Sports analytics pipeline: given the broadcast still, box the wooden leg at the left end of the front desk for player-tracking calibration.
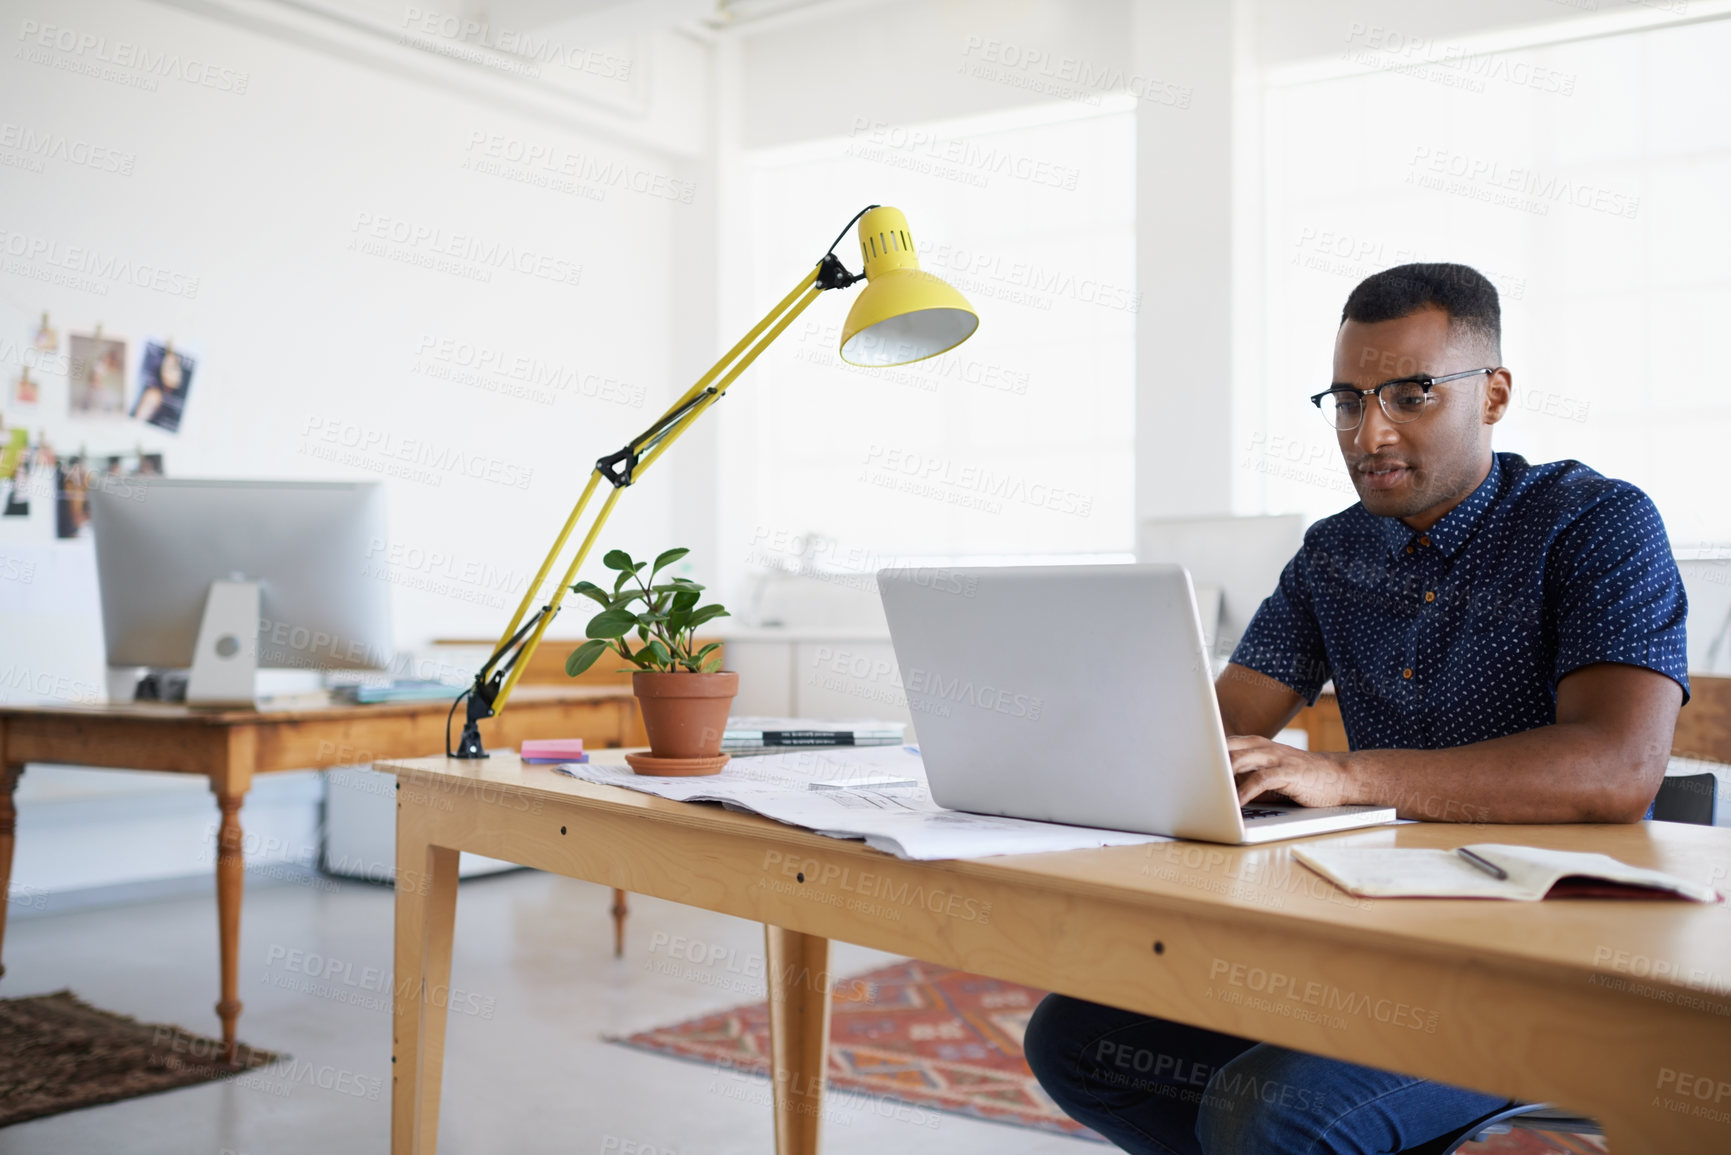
[391,820,457,1155]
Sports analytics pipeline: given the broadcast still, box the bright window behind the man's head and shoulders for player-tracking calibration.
[1236,11,1731,549]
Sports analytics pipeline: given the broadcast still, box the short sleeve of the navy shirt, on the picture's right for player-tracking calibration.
[1551,485,1689,703]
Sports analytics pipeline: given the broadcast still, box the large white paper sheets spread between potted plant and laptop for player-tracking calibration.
[557,746,1168,861]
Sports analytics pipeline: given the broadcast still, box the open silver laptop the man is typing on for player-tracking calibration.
[878,565,1395,843]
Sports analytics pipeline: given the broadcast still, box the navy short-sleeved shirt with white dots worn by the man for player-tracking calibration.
[1232,454,1689,750]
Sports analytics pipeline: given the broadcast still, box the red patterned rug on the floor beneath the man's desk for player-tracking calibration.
[608,961,1605,1155]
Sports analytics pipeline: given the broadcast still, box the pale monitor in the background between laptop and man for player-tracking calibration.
[1136,514,1305,667]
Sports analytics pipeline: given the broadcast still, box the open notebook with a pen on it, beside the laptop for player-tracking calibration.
[1293,842,1719,902]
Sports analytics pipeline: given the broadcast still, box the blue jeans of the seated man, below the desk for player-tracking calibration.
[1023,994,1508,1155]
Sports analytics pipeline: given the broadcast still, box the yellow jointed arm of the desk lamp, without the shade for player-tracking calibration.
[447,254,837,758]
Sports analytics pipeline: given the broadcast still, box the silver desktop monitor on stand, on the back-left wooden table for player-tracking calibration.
[90,478,391,703]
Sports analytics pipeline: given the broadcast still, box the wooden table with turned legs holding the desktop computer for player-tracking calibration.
[0,686,637,1055]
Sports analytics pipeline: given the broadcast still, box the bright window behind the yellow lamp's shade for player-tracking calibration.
[724,107,1139,571]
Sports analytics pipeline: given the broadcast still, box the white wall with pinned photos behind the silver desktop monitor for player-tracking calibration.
[0,0,713,885]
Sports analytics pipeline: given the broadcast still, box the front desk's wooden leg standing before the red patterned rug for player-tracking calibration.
[763,925,829,1155]
